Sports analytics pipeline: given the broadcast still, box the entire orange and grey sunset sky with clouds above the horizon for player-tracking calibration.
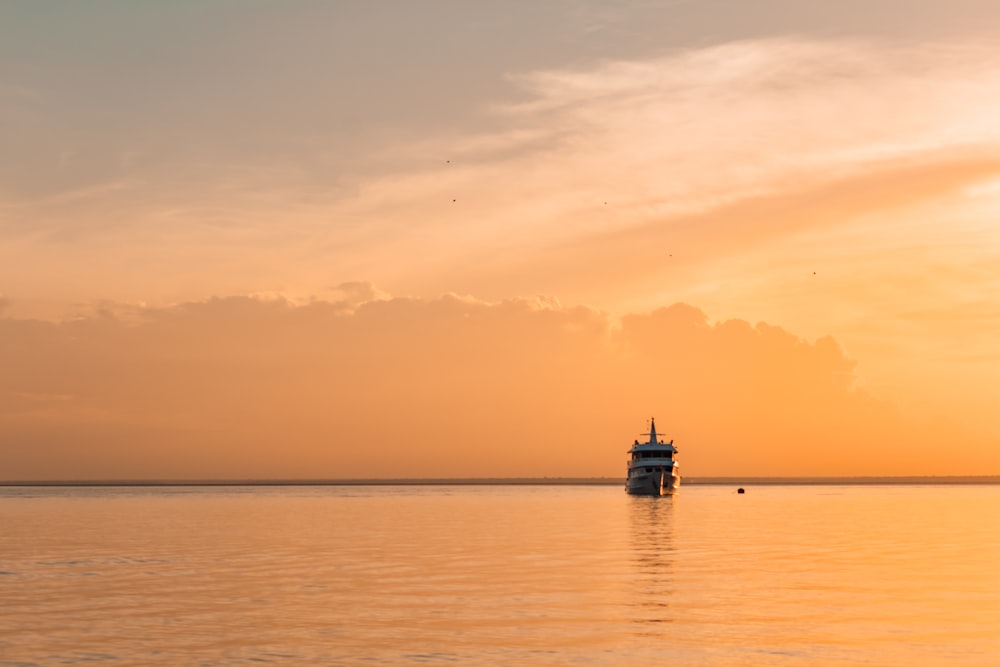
[0,0,1000,480]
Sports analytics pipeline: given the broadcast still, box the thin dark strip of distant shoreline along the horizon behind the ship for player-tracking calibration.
[0,475,1000,487]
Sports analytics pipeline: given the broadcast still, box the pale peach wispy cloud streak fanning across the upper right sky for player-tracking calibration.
[335,39,1000,278]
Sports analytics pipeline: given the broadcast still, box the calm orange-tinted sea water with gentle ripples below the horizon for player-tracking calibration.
[0,486,1000,666]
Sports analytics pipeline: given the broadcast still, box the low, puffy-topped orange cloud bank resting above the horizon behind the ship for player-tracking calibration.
[0,294,1000,479]
